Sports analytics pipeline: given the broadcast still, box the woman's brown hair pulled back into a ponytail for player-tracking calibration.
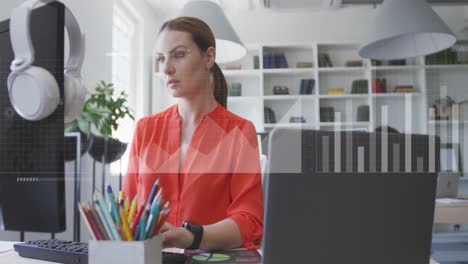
[159,17,227,108]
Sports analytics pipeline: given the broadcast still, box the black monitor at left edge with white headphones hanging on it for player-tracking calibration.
[0,2,65,233]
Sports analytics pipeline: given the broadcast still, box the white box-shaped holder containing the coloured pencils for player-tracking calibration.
[88,235,162,264]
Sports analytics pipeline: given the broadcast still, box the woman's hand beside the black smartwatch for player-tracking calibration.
[161,222,195,248]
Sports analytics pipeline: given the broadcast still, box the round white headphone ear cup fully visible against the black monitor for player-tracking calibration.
[8,66,60,121]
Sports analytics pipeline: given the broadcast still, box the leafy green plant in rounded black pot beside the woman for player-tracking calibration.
[86,81,135,163]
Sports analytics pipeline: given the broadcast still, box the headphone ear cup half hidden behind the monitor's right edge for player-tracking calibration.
[64,73,88,123]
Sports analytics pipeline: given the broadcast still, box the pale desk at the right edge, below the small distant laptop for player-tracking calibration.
[434,200,468,224]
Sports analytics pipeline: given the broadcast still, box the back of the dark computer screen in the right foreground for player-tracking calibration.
[262,128,439,264]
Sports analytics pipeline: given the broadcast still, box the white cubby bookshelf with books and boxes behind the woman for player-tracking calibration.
[154,42,468,137]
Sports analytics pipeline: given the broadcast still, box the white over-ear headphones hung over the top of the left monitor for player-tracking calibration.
[8,0,88,123]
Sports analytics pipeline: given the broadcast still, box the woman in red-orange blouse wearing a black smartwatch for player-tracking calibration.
[124,17,263,250]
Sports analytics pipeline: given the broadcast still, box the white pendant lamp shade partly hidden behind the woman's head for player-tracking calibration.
[181,0,247,63]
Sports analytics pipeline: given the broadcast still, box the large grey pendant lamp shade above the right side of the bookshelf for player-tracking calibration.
[359,0,456,60]
